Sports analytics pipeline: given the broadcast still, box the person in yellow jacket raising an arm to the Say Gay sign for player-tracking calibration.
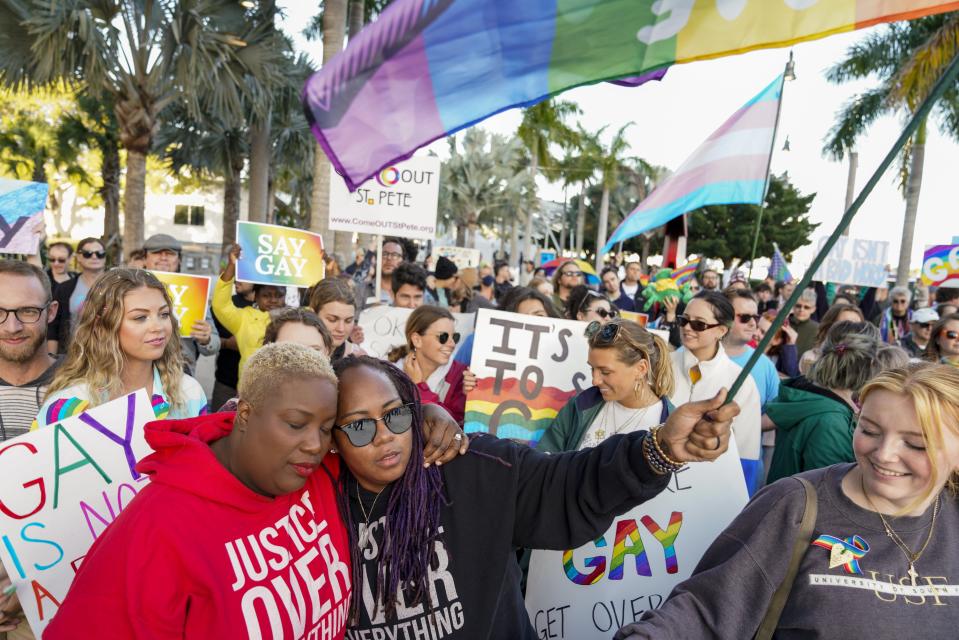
[213,244,286,379]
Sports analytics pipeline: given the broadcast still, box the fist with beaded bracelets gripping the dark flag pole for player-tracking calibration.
[658,389,739,462]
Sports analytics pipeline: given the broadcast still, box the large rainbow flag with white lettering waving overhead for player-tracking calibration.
[303,0,959,190]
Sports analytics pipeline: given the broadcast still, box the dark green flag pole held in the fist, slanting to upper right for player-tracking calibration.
[726,54,959,403]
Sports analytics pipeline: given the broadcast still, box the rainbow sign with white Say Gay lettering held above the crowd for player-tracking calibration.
[236,220,326,287]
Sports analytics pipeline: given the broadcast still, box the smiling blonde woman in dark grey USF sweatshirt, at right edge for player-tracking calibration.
[616,364,959,640]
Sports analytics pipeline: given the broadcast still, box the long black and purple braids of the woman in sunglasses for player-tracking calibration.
[333,356,448,624]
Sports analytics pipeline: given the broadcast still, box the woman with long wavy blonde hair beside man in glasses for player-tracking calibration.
[37,269,207,426]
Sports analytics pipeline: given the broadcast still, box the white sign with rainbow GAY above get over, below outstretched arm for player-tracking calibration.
[526,440,748,640]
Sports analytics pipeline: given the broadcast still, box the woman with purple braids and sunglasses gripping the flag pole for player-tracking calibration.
[333,357,739,640]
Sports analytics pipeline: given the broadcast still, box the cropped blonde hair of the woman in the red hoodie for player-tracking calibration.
[237,342,337,406]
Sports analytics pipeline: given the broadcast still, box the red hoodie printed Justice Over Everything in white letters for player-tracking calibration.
[43,413,351,640]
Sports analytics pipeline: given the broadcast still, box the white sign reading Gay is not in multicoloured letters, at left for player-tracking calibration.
[0,389,156,638]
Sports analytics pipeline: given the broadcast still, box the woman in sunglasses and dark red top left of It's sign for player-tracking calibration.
[387,305,476,424]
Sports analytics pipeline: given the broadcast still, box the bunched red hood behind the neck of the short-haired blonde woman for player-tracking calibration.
[137,413,339,511]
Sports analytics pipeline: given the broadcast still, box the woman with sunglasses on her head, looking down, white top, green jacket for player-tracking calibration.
[536,320,673,453]
